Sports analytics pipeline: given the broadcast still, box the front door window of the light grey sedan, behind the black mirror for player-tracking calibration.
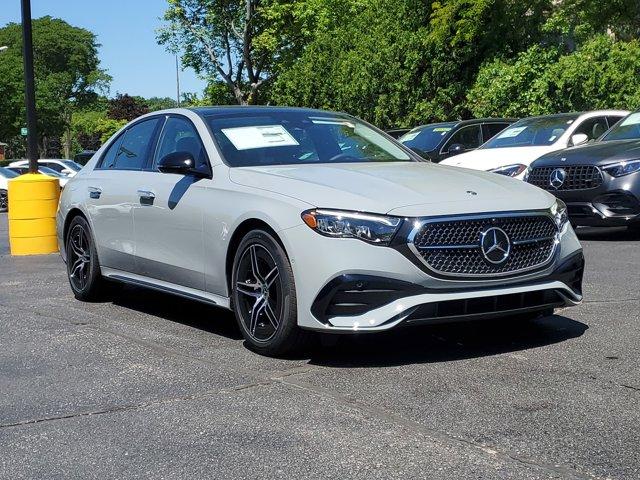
[154,117,207,168]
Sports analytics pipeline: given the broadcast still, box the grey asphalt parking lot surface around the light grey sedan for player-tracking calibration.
[0,214,640,479]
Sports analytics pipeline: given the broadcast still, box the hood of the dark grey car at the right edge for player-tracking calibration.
[535,140,640,167]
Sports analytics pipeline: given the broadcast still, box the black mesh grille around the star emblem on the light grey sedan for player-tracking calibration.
[413,214,557,277]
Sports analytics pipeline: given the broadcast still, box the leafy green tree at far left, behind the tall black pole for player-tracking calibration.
[0,17,110,156]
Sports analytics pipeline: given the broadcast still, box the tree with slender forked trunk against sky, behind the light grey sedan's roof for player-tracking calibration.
[158,0,318,104]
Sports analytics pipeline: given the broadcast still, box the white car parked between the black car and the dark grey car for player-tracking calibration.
[444,110,629,180]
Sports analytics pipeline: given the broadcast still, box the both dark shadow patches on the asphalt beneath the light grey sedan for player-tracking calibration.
[105,286,589,368]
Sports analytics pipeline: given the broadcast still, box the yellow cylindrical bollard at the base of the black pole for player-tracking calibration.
[8,173,60,255]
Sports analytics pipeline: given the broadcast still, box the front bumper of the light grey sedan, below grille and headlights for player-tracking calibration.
[281,219,584,332]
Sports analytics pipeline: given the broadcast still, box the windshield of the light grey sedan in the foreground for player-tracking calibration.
[205,110,413,167]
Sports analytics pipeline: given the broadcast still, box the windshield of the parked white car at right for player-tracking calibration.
[480,114,579,148]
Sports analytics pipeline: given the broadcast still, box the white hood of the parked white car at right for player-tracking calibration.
[440,145,558,170]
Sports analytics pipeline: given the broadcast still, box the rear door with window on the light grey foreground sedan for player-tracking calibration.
[85,117,160,272]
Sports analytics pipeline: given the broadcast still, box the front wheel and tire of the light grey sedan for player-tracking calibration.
[231,230,310,356]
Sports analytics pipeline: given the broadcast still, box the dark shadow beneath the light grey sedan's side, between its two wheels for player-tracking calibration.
[109,285,243,340]
